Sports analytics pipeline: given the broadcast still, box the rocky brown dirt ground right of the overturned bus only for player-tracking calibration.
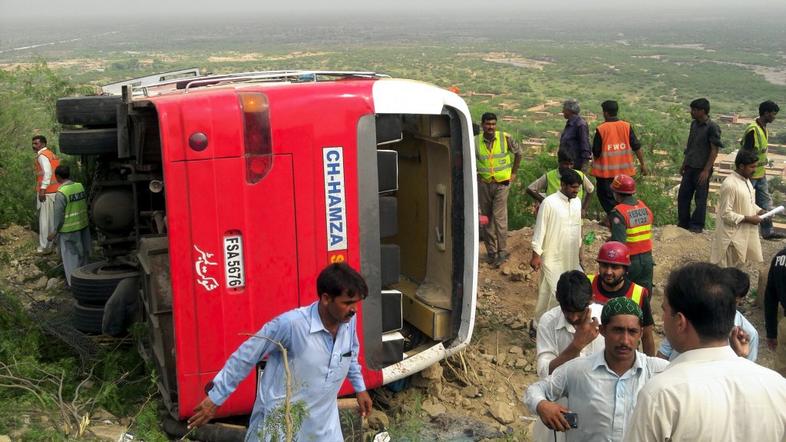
[372,221,786,440]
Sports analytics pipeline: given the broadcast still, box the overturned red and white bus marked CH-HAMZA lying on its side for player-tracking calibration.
[58,71,478,419]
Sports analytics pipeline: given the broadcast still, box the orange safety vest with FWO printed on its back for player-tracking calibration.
[591,120,636,178]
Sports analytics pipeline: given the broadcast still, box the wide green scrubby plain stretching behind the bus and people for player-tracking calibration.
[0,16,786,228]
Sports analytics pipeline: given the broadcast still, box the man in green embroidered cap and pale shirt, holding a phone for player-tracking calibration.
[524,297,668,441]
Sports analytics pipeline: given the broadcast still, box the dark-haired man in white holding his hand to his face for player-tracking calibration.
[532,270,604,442]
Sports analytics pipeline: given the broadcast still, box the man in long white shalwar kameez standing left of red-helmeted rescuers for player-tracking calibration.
[530,169,582,326]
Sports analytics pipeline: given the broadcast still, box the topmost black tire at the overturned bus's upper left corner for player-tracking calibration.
[56,95,123,126]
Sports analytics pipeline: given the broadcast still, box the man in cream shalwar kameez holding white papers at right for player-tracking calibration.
[710,150,764,268]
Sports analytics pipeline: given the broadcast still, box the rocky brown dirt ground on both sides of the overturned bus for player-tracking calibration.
[0,221,786,441]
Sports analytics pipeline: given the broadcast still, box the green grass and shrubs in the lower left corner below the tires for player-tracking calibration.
[0,278,166,441]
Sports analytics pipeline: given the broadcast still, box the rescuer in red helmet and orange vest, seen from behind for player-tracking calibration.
[609,174,655,293]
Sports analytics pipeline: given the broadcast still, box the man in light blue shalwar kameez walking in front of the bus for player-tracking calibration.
[188,263,371,442]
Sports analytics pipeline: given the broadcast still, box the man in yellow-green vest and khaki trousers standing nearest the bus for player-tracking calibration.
[475,112,521,267]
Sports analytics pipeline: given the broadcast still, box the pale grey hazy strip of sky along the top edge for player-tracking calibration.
[0,0,786,21]
